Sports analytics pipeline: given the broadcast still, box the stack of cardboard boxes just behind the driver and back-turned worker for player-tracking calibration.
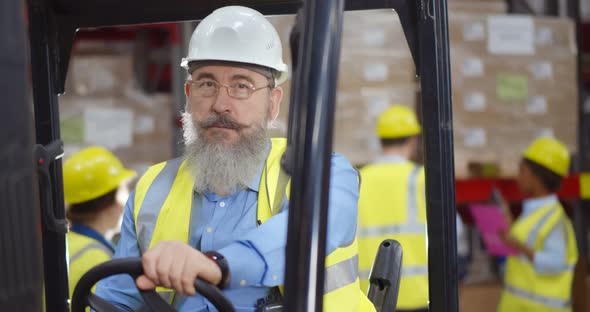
[270,10,418,165]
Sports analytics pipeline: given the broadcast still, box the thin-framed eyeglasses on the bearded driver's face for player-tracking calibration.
[186,79,271,100]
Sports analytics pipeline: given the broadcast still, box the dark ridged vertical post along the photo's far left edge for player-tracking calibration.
[0,1,43,312]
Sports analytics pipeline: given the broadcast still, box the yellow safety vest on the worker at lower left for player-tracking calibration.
[66,232,113,298]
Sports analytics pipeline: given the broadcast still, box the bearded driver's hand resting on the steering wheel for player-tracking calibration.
[136,241,221,296]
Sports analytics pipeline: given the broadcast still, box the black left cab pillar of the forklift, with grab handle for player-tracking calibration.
[28,0,69,312]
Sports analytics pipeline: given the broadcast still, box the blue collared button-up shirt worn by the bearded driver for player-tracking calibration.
[96,154,359,311]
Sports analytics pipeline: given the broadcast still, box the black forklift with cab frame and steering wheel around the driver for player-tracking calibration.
[0,0,470,312]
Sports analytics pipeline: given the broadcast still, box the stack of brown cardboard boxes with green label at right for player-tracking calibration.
[449,13,578,177]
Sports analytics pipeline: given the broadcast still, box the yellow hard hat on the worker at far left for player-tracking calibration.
[63,146,136,204]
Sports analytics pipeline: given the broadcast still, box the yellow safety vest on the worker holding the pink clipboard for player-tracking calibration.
[498,203,578,312]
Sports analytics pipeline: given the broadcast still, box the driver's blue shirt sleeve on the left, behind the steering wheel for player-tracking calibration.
[96,192,143,311]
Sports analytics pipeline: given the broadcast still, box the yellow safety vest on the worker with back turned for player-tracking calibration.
[358,161,428,310]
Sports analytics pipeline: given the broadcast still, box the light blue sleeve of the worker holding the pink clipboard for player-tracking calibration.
[533,222,567,274]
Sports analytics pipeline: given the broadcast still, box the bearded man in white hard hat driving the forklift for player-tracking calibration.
[97,6,371,311]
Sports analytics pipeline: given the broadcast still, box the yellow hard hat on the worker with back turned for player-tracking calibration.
[377,105,422,139]
